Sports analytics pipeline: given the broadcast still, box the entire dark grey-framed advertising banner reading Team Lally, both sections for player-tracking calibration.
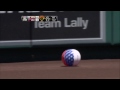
[0,11,106,47]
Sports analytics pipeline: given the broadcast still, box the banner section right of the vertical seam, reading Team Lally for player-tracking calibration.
[31,11,106,45]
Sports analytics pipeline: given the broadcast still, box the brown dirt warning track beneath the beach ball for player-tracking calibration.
[0,59,120,79]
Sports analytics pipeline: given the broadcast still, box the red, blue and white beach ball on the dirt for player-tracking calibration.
[62,49,81,66]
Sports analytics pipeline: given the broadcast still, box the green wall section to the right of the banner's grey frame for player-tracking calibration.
[106,11,120,44]
